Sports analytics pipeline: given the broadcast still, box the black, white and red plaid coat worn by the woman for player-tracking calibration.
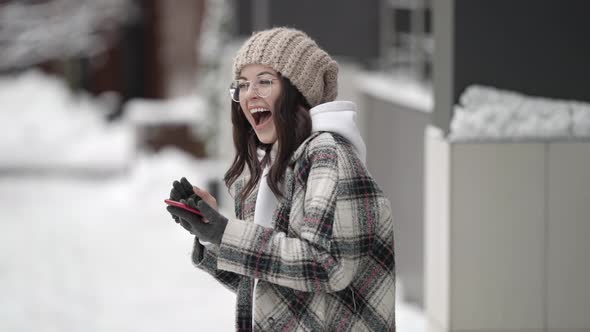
[193,132,395,331]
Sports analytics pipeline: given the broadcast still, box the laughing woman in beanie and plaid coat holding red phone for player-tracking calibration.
[167,28,395,331]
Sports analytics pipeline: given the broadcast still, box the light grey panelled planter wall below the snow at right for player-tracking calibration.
[424,129,590,331]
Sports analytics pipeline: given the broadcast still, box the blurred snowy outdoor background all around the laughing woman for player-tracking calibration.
[0,0,590,332]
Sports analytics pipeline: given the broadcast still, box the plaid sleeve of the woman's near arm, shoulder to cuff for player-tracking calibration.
[213,144,359,292]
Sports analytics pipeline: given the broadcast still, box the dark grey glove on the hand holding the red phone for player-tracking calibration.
[166,197,227,245]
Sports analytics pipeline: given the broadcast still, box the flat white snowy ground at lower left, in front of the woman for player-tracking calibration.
[0,151,235,332]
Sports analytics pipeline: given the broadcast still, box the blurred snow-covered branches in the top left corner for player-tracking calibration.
[0,0,137,69]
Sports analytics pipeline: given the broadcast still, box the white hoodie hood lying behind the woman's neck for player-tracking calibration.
[309,100,367,164]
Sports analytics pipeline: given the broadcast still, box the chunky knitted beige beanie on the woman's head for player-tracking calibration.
[234,27,338,107]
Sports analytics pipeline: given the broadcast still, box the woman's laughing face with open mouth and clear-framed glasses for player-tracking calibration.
[238,64,282,144]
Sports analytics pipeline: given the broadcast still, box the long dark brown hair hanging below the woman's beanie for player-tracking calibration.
[224,76,311,201]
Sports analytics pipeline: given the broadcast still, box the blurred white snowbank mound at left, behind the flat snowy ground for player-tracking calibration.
[0,70,135,169]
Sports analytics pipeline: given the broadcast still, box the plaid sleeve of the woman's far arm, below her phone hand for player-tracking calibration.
[192,237,241,293]
